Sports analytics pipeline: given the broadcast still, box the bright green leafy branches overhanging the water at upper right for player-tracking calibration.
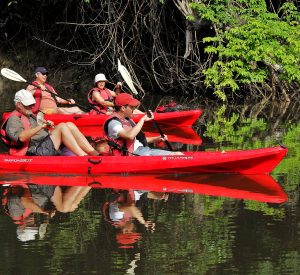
[188,0,300,100]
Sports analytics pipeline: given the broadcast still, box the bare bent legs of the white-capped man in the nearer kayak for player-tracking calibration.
[51,123,94,156]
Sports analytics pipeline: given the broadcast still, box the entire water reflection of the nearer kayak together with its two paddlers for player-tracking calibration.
[1,173,287,248]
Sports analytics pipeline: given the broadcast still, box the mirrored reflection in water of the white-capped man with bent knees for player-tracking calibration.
[2,184,91,242]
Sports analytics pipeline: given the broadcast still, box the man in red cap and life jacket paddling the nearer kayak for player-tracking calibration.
[104,93,182,156]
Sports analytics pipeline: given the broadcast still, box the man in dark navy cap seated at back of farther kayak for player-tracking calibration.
[26,67,84,114]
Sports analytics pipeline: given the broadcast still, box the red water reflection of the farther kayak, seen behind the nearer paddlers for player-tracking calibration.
[79,125,202,145]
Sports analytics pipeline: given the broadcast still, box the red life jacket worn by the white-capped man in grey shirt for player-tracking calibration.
[0,110,31,156]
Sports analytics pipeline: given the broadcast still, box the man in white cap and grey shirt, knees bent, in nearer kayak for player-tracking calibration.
[1,89,99,156]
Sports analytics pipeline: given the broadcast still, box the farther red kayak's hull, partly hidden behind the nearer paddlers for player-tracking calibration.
[41,110,202,127]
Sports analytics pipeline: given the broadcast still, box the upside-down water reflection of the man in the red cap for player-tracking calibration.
[103,189,168,248]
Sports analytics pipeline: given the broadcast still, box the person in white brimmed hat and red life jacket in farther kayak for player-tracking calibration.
[88,74,122,114]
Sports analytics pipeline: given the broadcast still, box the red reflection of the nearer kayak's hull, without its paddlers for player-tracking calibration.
[0,173,288,203]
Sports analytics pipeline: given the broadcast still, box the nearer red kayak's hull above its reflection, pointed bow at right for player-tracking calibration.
[0,146,287,175]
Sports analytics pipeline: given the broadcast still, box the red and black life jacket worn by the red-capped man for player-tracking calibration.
[103,113,148,156]
